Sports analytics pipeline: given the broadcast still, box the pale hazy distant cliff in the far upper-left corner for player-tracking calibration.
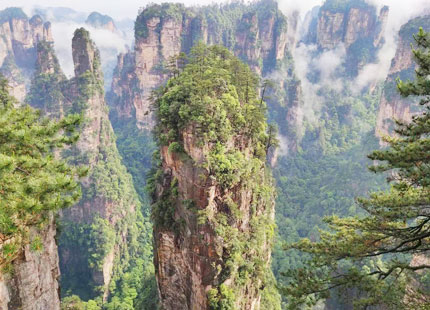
[0,8,53,101]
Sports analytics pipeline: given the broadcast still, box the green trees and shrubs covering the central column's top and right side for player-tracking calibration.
[148,44,279,310]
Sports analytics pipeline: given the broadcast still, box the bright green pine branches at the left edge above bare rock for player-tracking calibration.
[0,75,84,265]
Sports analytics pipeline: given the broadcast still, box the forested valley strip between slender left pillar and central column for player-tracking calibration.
[109,122,158,310]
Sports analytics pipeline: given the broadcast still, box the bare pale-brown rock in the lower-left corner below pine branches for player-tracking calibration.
[0,215,60,310]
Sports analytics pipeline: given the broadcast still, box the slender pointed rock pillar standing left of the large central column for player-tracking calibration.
[53,29,140,300]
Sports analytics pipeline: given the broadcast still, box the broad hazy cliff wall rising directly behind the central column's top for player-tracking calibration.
[109,1,297,129]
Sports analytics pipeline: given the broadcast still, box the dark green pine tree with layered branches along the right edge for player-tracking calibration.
[283,29,430,309]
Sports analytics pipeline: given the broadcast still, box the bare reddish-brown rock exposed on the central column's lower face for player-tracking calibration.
[154,121,274,310]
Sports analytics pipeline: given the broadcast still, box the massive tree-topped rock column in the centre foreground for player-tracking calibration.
[150,45,276,310]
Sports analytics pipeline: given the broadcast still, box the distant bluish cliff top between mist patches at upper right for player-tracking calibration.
[316,0,388,49]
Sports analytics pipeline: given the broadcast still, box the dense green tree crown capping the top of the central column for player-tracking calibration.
[151,45,265,148]
